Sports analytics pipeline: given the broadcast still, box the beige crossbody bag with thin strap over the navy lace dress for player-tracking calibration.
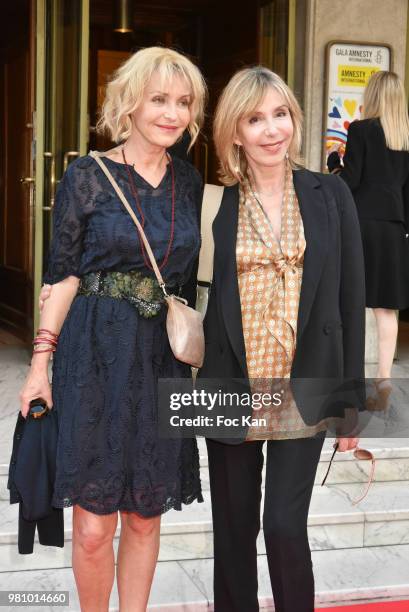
[90,151,223,368]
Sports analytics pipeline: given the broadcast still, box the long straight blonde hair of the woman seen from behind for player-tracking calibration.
[363,70,409,151]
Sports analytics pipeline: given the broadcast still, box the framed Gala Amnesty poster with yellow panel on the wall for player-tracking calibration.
[323,41,392,169]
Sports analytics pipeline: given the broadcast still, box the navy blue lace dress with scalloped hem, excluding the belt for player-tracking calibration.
[44,156,203,517]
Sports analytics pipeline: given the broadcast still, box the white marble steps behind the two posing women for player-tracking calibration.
[0,439,409,612]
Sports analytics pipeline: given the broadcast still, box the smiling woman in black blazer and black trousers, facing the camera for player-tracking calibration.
[199,67,365,612]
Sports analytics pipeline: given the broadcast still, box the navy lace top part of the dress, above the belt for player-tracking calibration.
[44,155,202,286]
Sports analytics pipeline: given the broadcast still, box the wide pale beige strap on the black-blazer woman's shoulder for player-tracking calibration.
[197,183,224,286]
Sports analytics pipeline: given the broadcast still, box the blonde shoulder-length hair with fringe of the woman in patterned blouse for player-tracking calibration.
[213,66,303,185]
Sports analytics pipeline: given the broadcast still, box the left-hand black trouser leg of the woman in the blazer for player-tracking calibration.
[206,440,263,612]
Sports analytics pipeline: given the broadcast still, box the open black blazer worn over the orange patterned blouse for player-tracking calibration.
[199,169,365,443]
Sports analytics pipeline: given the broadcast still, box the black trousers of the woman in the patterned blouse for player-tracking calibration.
[206,432,325,612]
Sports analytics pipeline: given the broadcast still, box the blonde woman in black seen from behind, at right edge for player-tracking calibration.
[328,71,409,396]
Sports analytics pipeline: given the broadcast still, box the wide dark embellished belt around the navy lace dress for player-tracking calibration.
[78,270,181,319]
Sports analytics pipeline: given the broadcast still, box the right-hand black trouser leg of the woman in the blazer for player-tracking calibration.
[263,432,325,612]
